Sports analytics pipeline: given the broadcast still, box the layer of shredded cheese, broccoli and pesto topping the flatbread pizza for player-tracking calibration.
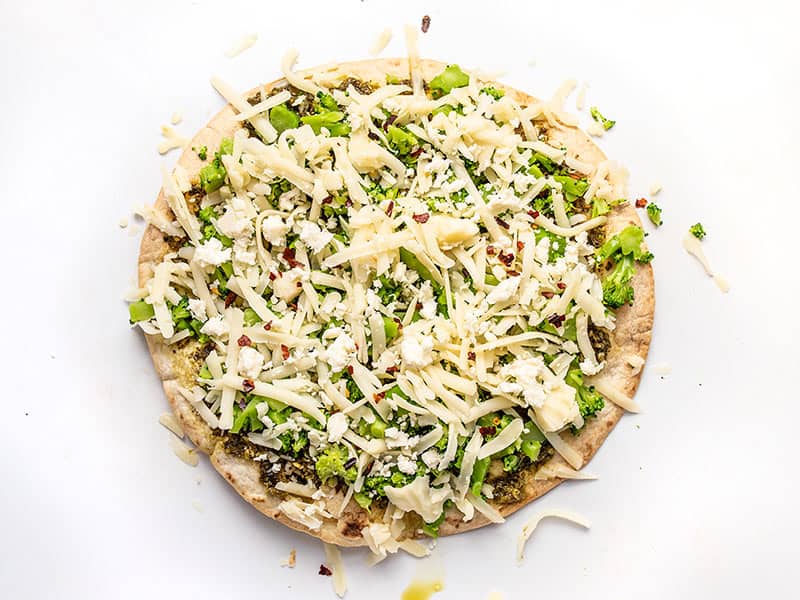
[130,59,652,547]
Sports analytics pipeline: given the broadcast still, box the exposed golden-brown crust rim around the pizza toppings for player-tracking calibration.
[138,58,655,546]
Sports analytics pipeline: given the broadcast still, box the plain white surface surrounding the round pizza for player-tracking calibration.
[0,0,800,600]
